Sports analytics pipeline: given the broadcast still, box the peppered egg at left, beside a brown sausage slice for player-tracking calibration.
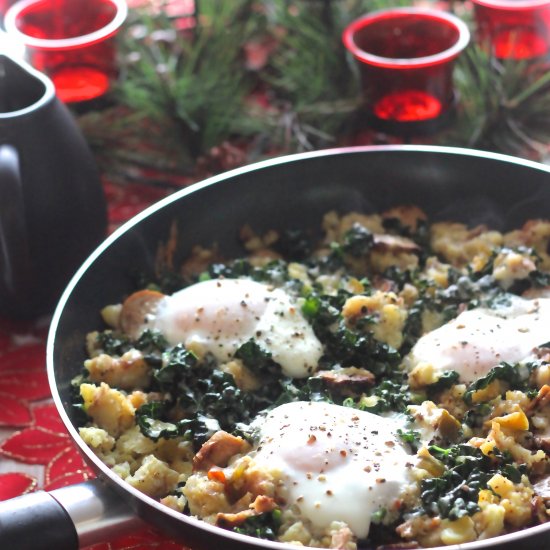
[147,279,323,378]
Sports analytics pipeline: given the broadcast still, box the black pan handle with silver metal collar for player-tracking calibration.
[0,479,141,550]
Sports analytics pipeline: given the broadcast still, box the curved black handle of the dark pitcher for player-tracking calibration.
[0,145,31,309]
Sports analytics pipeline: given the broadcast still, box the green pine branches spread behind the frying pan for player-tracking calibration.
[78,0,550,186]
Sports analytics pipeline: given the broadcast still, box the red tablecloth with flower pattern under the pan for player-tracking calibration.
[0,180,192,550]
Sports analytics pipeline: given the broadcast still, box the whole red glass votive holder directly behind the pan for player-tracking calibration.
[343,8,470,134]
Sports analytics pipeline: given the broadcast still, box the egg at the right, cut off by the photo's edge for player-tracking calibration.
[407,296,550,383]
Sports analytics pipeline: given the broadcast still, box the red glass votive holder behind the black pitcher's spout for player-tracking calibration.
[5,0,128,103]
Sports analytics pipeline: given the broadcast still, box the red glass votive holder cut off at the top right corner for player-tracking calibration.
[473,0,550,60]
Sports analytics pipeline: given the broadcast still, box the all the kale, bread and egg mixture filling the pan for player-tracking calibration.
[74,206,550,550]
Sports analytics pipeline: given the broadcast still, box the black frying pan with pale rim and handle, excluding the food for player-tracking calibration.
[0,146,550,550]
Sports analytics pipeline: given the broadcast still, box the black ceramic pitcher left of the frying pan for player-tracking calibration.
[0,53,107,317]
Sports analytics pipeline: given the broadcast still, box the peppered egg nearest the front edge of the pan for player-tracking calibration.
[255,402,415,538]
